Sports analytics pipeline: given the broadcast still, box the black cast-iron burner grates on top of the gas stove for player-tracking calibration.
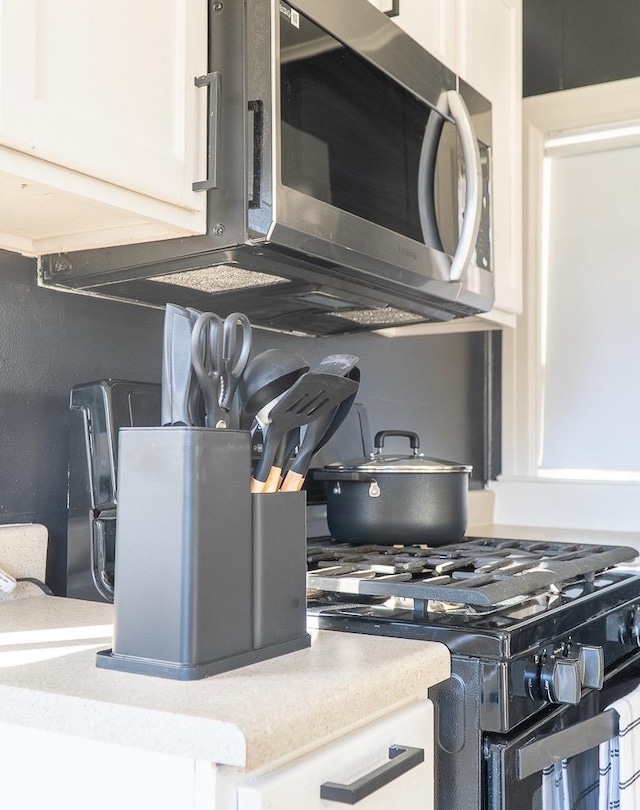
[307,537,636,614]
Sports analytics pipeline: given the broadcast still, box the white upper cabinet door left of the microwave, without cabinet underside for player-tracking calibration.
[0,0,207,209]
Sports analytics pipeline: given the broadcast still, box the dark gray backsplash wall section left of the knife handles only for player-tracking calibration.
[0,251,163,592]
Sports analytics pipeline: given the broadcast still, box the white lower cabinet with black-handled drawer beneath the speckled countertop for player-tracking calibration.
[0,700,434,810]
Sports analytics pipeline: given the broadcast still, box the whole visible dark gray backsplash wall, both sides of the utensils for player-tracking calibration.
[0,251,484,593]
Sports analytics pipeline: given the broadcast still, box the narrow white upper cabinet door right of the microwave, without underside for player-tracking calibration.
[457,0,522,322]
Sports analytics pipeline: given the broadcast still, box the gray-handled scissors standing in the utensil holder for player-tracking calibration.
[191,312,251,429]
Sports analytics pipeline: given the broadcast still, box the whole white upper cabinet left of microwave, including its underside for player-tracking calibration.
[0,0,207,255]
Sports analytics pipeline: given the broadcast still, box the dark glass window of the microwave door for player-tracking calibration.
[280,3,450,252]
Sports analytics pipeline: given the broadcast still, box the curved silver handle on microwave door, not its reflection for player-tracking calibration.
[447,90,482,281]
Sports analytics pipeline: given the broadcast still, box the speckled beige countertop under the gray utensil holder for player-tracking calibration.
[0,596,449,769]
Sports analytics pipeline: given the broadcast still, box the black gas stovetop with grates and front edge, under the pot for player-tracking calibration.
[307,537,640,658]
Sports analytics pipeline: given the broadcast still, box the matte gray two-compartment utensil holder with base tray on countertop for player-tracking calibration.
[97,427,309,680]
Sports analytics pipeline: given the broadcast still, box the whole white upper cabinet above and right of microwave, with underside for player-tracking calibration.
[372,0,522,335]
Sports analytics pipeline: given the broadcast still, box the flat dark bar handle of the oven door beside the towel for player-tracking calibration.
[517,709,620,779]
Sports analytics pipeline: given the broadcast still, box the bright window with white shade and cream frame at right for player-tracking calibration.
[492,78,640,542]
